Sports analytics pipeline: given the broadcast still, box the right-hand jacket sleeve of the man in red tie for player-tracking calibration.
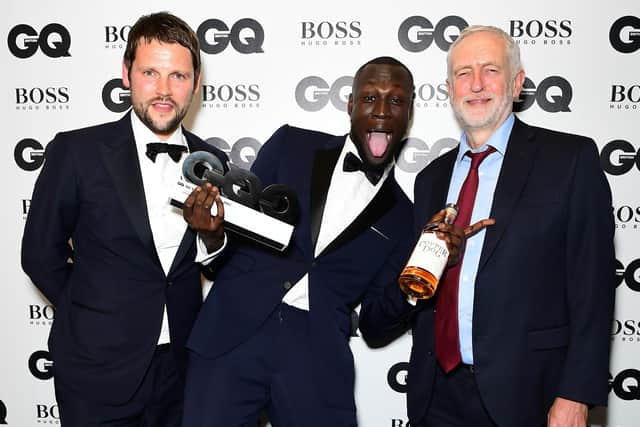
[558,140,615,405]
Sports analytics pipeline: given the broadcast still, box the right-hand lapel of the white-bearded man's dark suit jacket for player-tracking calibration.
[478,119,538,271]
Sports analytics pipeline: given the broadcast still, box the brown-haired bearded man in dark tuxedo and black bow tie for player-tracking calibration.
[22,13,226,427]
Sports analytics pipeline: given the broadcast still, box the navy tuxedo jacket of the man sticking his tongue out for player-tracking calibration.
[188,126,412,409]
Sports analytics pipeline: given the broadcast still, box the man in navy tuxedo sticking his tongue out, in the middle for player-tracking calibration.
[184,57,468,427]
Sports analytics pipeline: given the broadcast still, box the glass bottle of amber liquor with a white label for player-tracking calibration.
[398,203,458,299]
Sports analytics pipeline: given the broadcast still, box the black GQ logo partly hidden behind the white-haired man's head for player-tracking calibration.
[513,76,573,113]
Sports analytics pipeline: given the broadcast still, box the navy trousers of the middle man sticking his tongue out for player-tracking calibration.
[183,303,356,427]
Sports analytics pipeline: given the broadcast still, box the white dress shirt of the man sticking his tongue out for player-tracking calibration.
[282,135,393,311]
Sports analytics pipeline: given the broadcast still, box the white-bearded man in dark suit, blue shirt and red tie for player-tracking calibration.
[360,26,615,427]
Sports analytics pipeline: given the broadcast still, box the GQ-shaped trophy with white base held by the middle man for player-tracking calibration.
[171,151,299,251]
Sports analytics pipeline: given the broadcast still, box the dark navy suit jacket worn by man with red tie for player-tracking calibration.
[360,119,615,427]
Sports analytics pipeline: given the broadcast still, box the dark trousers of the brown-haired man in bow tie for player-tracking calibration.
[55,344,184,427]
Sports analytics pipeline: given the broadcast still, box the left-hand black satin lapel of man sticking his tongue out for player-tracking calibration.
[310,136,345,252]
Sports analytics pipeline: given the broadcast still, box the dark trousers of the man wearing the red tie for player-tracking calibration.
[411,365,500,427]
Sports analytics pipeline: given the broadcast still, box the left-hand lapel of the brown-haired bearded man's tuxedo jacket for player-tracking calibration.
[100,113,157,258]
